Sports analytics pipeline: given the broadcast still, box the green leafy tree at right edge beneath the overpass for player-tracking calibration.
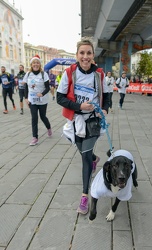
[136,51,152,78]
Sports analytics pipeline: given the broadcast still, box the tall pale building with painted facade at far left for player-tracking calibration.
[0,0,24,74]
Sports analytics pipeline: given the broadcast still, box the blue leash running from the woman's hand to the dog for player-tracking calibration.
[89,102,114,156]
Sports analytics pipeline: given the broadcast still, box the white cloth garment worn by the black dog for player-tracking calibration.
[91,149,135,201]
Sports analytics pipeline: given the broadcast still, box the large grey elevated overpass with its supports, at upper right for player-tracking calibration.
[81,0,152,72]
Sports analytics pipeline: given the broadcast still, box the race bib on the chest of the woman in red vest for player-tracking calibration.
[74,84,94,104]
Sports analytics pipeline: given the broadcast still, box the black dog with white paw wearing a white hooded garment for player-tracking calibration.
[89,150,138,221]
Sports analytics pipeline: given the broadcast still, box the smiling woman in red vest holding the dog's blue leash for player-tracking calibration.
[57,40,109,214]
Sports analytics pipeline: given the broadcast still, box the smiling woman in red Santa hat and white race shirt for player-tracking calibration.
[23,55,52,146]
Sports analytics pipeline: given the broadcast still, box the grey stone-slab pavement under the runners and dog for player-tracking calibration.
[0,92,152,250]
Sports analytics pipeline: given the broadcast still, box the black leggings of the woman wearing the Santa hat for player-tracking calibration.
[29,104,51,138]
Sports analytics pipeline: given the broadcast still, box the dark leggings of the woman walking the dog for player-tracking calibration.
[75,136,98,194]
